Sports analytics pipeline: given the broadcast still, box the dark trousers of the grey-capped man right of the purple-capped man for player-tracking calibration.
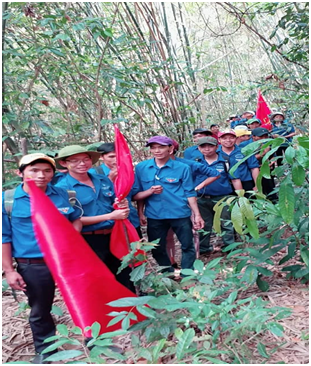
[198,196,234,254]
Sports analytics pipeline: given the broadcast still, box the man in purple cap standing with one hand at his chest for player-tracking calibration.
[134,136,204,272]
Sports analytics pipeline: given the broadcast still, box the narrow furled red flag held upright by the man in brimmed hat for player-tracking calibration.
[110,125,144,259]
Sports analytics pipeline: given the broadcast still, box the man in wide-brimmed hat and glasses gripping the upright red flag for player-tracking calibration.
[55,145,135,292]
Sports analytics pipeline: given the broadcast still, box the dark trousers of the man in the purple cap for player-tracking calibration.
[147,217,195,272]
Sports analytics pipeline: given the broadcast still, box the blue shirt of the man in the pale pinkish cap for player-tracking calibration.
[219,145,259,182]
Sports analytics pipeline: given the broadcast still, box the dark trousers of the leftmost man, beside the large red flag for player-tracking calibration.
[17,263,57,357]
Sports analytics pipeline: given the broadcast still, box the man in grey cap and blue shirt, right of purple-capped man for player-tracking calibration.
[195,136,242,255]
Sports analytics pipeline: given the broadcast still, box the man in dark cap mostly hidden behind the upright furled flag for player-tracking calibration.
[89,142,143,238]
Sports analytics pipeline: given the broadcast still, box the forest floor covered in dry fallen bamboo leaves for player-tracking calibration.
[2,238,309,364]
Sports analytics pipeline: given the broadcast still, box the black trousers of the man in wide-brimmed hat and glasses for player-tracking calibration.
[82,233,135,293]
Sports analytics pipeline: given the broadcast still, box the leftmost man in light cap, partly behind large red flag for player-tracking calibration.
[2,153,82,364]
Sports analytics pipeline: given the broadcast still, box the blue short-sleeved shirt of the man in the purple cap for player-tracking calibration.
[136,159,196,220]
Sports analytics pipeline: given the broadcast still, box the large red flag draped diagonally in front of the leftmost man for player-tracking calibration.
[27,181,145,337]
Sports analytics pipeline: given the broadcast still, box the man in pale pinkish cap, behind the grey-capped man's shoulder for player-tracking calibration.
[219,130,259,196]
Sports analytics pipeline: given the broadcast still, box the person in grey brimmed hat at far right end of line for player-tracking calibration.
[270,112,296,166]
